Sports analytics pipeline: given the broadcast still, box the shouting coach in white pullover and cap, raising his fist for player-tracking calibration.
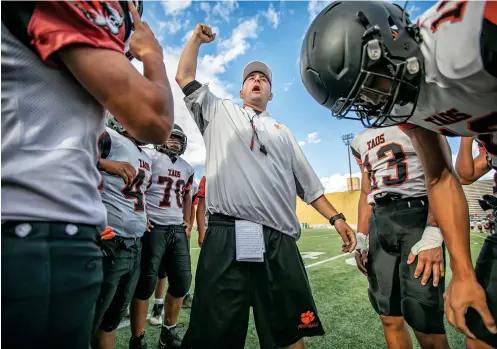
[176,24,356,349]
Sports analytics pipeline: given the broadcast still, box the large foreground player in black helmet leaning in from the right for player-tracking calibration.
[300,1,497,348]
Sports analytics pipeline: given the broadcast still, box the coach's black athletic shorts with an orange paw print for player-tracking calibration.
[182,215,324,349]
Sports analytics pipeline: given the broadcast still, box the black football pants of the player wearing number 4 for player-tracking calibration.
[94,237,141,332]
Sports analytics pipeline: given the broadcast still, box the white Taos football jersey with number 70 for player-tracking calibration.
[143,148,194,225]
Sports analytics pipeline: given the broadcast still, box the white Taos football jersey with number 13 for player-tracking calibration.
[350,126,427,204]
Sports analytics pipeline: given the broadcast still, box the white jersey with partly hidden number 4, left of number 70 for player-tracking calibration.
[100,127,152,238]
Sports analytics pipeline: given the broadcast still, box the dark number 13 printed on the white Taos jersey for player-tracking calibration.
[363,143,408,191]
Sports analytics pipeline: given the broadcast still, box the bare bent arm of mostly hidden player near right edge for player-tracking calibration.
[456,137,491,184]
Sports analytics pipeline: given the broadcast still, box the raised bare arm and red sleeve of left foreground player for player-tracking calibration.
[26,1,174,144]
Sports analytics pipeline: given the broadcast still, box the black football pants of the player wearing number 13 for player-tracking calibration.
[367,199,445,333]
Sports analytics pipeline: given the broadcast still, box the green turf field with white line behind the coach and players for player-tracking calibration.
[116,229,486,349]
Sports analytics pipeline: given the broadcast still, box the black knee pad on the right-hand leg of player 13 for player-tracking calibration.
[401,297,445,334]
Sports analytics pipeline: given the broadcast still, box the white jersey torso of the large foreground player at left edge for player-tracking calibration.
[1,21,107,228]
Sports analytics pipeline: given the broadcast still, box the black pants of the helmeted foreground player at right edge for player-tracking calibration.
[466,234,497,348]
